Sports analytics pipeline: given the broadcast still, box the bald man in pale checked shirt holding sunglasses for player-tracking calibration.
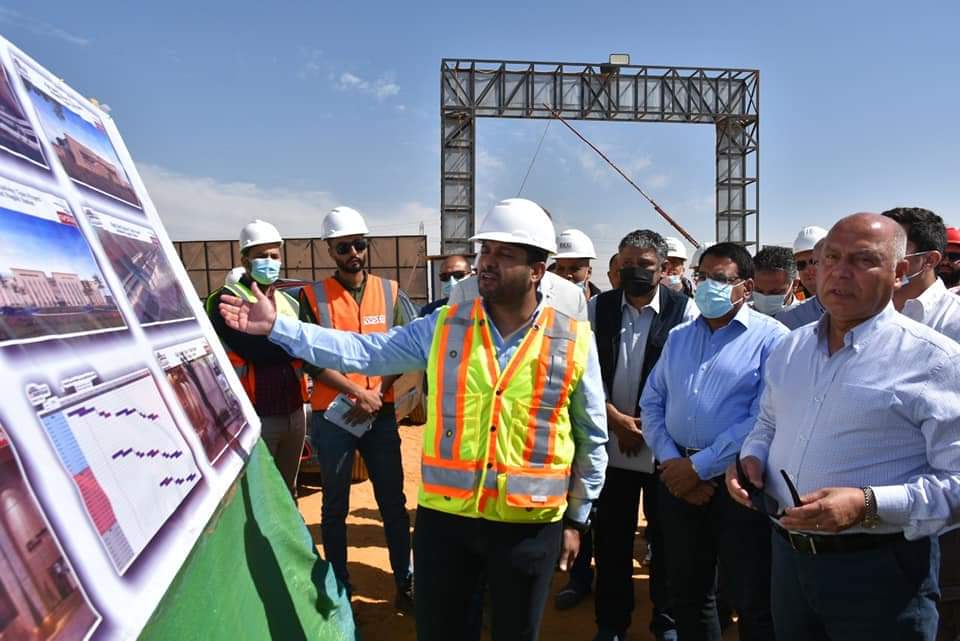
[727,213,960,641]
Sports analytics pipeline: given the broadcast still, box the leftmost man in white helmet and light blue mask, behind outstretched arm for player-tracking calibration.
[206,220,307,495]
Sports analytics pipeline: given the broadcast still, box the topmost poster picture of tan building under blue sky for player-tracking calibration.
[20,65,141,208]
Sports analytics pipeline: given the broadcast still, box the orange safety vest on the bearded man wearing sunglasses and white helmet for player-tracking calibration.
[301,274,399,410]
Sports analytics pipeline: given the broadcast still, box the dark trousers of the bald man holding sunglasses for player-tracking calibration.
[771,533,940,641]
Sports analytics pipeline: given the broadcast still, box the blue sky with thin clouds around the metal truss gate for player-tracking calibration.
[0,0,960,284]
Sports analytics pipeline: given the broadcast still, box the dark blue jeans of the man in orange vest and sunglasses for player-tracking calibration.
[310,404,412,586]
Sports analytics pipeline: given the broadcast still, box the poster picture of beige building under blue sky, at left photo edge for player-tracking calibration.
[0,178,126,345]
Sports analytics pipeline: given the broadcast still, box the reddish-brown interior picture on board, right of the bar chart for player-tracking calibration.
[157,338,247,463]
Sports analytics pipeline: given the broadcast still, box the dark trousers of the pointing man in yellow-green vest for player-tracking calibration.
[413,507,563,641]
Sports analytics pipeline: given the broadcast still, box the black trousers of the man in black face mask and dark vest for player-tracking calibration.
[594,467,674,635]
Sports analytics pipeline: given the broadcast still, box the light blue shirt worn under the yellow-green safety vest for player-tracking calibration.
[270,303,607,523]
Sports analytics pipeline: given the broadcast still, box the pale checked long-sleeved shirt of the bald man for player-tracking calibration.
[740,304,960,539]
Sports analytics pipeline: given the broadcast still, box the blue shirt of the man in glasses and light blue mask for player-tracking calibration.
[640,305,788,480]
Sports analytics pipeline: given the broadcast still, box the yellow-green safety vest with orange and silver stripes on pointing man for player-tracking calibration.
[418,298,593,523]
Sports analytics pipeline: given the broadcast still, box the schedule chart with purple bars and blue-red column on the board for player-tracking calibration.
[26,370,201,574]
